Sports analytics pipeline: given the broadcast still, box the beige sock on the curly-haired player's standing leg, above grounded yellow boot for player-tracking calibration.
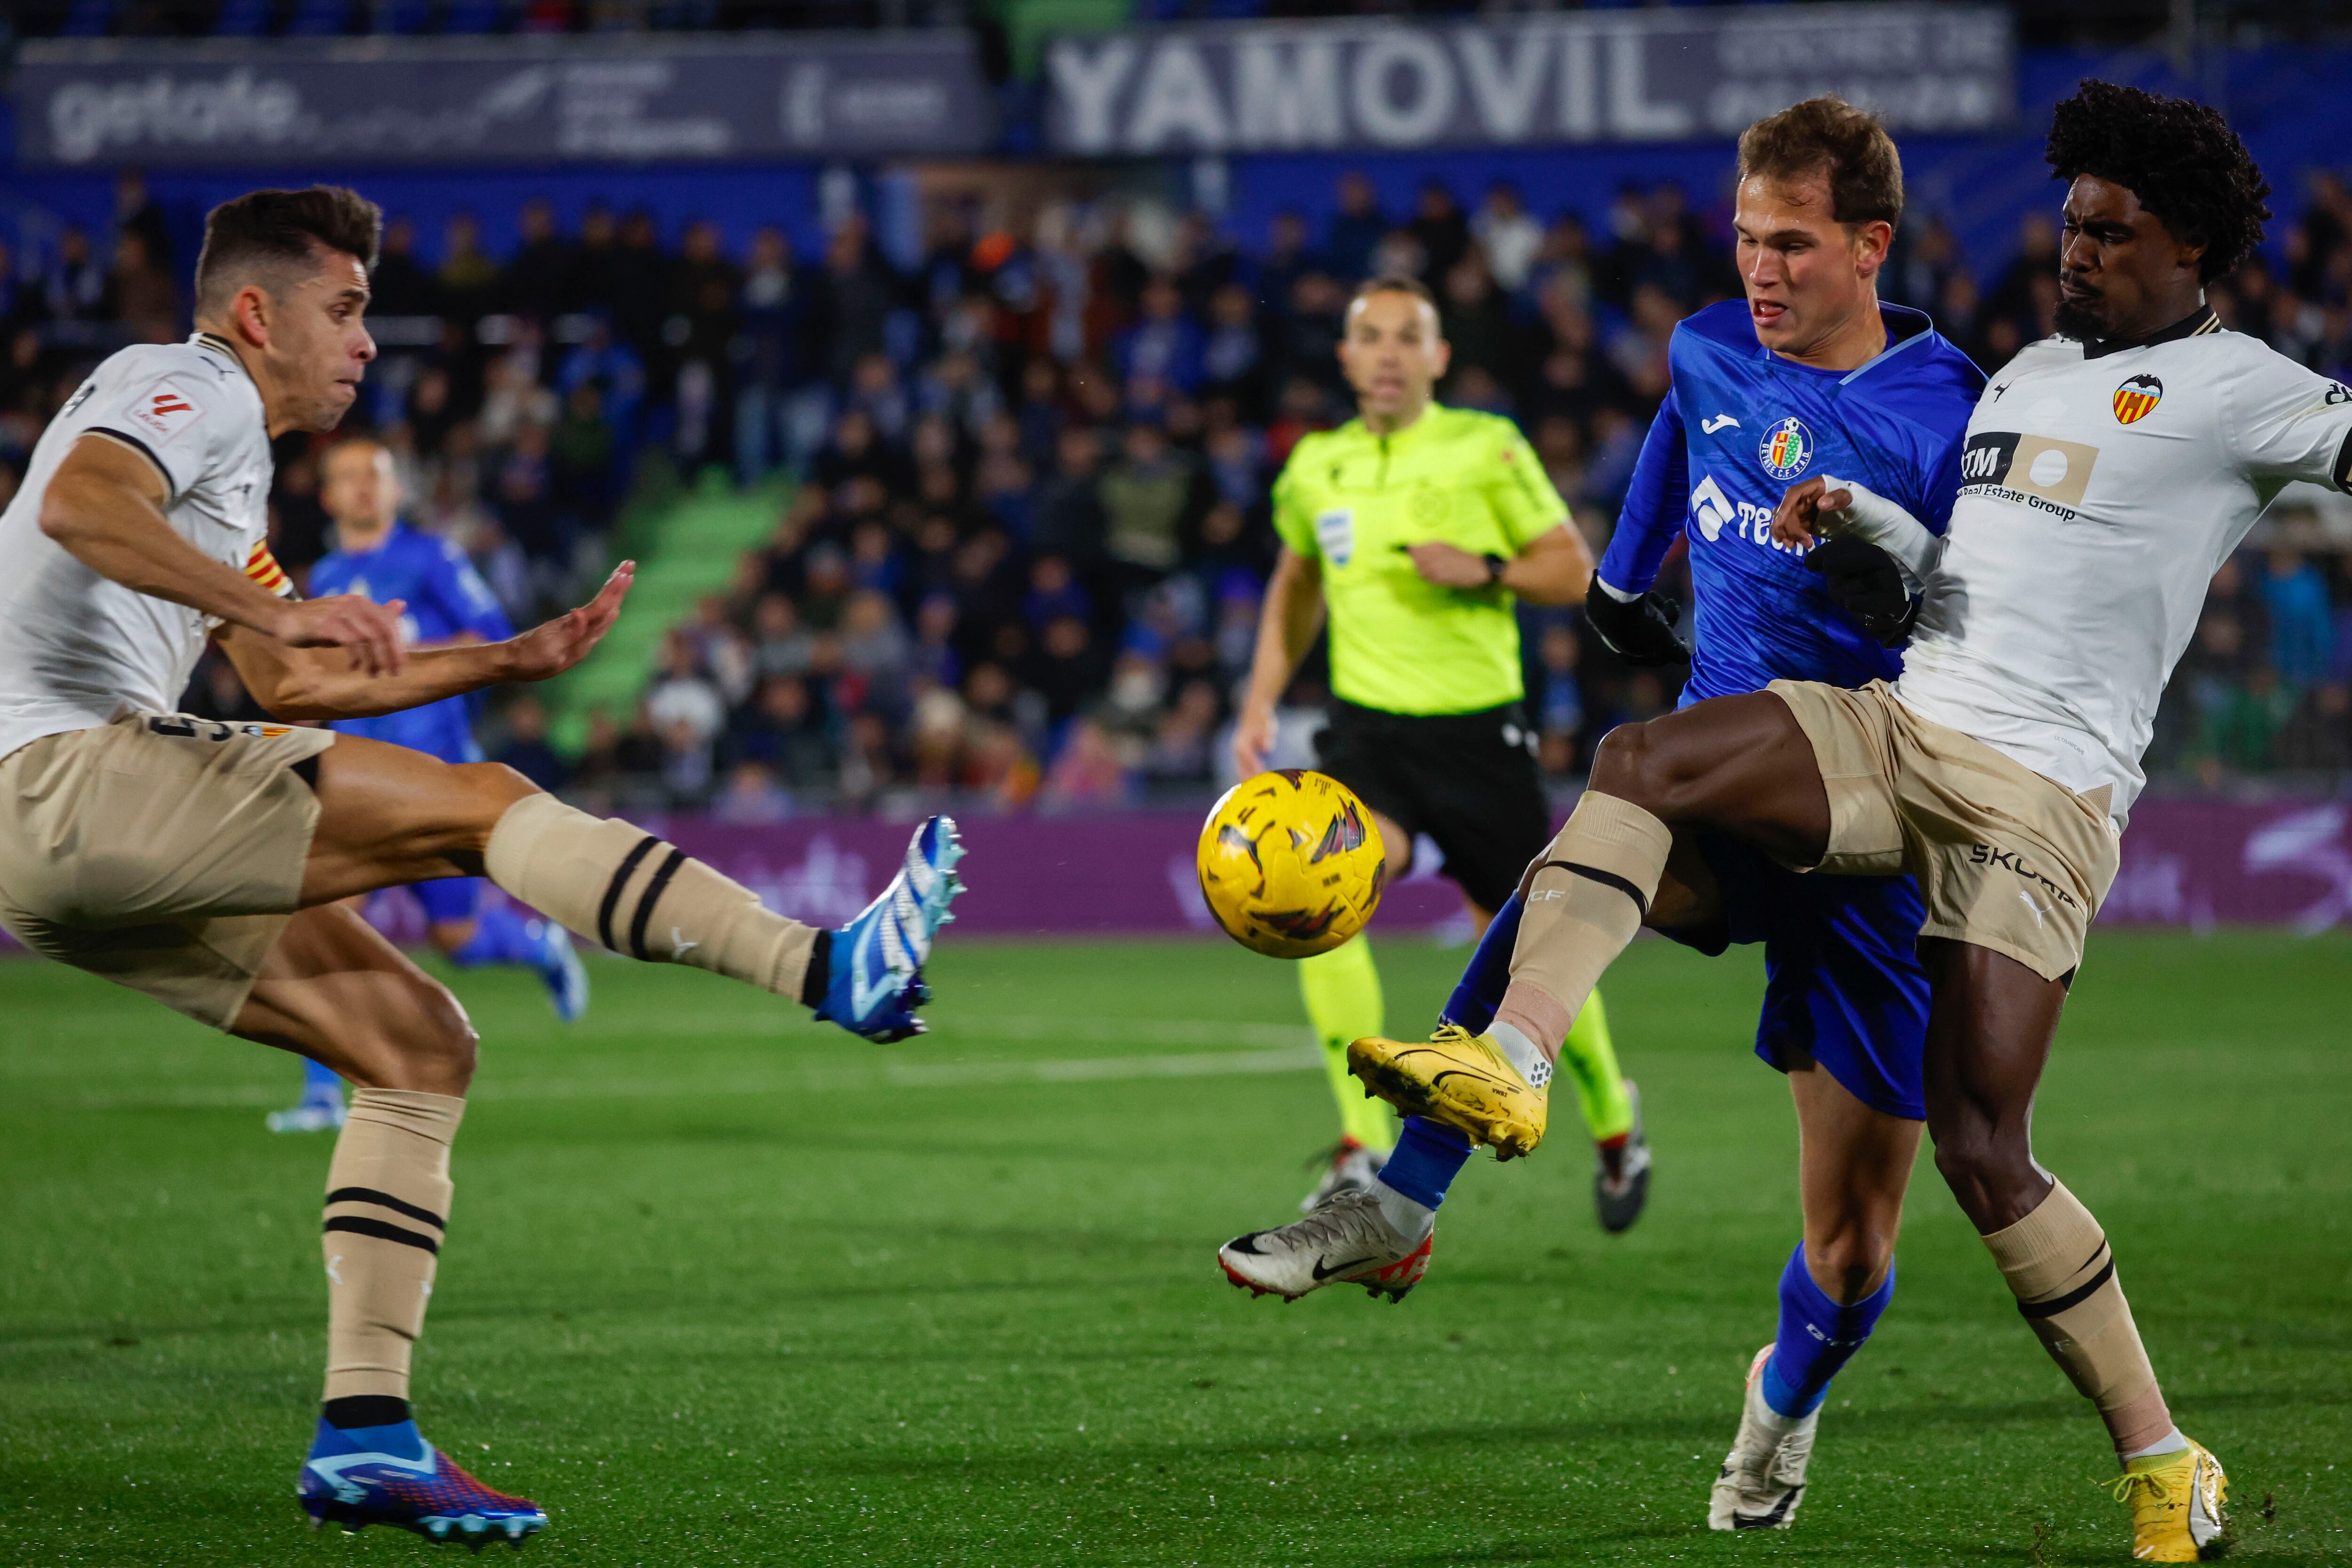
[1985,1182,2171,1427]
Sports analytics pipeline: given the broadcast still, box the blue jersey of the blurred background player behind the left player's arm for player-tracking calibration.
[310,522,515,762]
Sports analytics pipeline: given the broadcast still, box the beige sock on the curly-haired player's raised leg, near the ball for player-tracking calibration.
[1494,790,1675,1062]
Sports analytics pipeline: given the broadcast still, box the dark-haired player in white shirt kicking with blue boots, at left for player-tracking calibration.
[0,186,960,1547]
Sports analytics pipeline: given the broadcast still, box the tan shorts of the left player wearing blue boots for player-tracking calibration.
[0,713,334,1029]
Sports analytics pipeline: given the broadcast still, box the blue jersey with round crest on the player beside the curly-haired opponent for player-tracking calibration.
[1602,299,1985,705]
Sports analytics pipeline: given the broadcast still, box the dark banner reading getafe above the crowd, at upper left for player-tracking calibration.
[14,31,993,169]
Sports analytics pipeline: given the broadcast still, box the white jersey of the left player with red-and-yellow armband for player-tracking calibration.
[0,334,289,757]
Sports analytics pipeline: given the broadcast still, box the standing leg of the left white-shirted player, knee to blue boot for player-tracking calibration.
[230,905,548,1547]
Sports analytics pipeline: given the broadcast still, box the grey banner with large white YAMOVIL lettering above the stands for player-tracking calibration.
[1047,5,2016,158]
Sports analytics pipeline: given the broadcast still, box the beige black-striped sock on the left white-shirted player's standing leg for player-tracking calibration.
[322,1088,466,1399]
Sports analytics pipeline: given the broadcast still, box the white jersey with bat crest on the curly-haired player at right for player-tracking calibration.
[1896,313,2352,827]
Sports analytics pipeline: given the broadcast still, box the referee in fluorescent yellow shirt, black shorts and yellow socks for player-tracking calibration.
[1232,277,1649,1229]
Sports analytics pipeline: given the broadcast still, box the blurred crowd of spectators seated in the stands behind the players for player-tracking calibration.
[0,174,2352,820]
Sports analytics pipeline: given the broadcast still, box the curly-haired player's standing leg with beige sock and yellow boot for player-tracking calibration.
[1919,938,2230,1563]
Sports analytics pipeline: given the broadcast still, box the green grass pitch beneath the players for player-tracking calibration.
[0,933,2352,1568]
